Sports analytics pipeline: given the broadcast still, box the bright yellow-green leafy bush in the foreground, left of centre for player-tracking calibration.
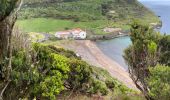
[33,44,69,100]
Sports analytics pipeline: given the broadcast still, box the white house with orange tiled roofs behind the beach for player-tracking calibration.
[55,28,87,39]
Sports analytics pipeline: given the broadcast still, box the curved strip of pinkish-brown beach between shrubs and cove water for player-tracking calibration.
[59,40,138,90]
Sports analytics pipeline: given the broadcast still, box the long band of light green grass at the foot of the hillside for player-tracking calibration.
[16,17,158,34]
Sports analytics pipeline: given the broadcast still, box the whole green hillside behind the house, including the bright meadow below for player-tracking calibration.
[17,0,159,34]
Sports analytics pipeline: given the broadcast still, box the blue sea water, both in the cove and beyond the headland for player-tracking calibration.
[96,0,170,70]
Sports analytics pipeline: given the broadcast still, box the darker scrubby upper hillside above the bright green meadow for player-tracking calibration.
[19,0,158,21]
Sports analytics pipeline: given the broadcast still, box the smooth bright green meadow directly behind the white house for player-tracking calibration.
[16,18,107,33]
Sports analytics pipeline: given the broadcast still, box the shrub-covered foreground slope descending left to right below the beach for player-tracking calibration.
[1,25,136,100]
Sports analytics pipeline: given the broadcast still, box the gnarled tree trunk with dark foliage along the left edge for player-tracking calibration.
[0,0,21,97]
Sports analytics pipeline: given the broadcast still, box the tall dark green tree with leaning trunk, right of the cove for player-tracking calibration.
[124,21,160,99]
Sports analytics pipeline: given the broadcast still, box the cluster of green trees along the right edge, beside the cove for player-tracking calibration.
[124,21,169,100]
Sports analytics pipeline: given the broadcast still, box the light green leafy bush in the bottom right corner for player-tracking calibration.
[147,65,170,100]
